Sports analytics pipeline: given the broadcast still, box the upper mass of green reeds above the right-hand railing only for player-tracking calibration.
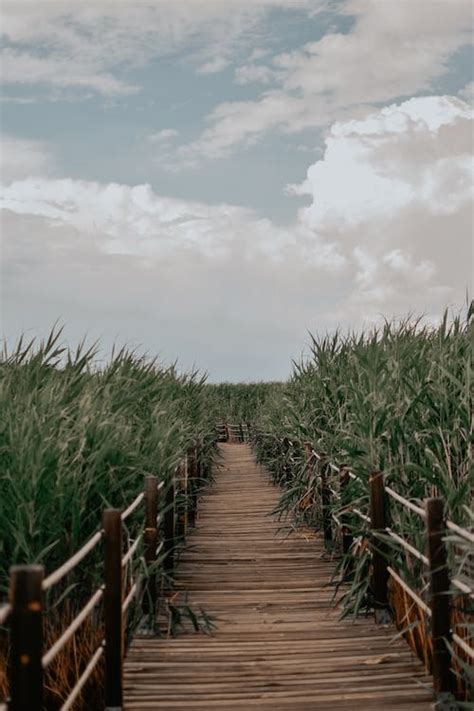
[254,314,474,521]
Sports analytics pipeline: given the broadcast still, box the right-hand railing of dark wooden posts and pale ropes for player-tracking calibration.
[250,431,474,694]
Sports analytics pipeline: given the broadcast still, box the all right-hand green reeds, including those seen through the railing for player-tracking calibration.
[256,307,474,700]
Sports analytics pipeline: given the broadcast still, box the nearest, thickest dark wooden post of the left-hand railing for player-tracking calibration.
[9,565,44,711]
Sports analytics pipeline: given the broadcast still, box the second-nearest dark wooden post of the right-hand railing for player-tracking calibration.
[369,472,388,622]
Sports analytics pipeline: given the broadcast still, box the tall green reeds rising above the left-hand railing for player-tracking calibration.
[0,330,214,593]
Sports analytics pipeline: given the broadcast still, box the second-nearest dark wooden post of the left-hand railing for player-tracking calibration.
[102,509,124,711]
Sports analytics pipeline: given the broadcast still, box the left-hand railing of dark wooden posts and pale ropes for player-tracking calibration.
[0,446,205,711]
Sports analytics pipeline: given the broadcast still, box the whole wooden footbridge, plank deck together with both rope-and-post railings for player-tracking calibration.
[0,436,474,711]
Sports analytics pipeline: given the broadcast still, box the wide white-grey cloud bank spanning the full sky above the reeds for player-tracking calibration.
[3,96,473,378]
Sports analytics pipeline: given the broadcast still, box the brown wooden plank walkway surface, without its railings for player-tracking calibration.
[125,444,431,711]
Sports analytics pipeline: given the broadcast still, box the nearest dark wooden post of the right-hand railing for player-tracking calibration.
[425,499,454,693]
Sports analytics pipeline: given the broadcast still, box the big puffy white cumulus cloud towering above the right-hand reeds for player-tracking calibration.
[289,96,474,320]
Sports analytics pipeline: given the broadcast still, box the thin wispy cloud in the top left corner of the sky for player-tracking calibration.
[2,0,318,96]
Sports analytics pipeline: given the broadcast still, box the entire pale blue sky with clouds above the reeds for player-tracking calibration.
[0,0,474,382]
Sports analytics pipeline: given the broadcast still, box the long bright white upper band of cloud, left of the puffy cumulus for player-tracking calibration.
[1,178,343,270]
